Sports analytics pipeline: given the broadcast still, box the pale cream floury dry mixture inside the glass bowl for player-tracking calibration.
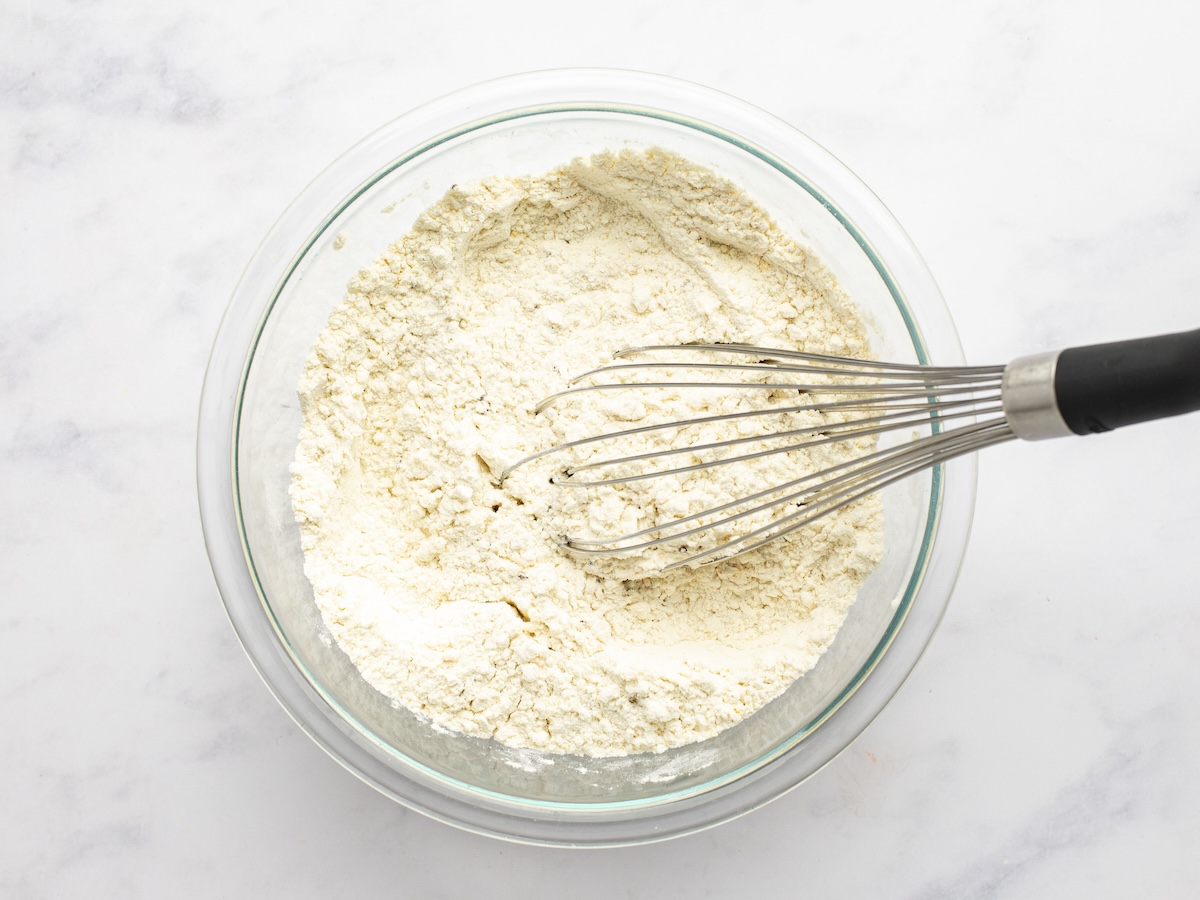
[292,150,883,756]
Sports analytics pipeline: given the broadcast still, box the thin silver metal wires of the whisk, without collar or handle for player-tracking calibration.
[500,344,1015,570]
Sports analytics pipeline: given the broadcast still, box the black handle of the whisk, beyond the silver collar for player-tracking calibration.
[1054,329,1200,434]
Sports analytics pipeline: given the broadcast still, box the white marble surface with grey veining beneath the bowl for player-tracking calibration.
[0,0,1200,898]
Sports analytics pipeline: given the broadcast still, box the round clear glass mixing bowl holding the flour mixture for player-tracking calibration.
[197,71,974,846]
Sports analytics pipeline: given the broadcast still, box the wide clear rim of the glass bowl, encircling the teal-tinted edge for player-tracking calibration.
[197,70,976,846]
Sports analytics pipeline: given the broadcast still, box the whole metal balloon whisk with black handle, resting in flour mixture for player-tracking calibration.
[502,330,1200,569]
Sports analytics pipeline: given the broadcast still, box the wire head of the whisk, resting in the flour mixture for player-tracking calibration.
[502,343,1014,570]
